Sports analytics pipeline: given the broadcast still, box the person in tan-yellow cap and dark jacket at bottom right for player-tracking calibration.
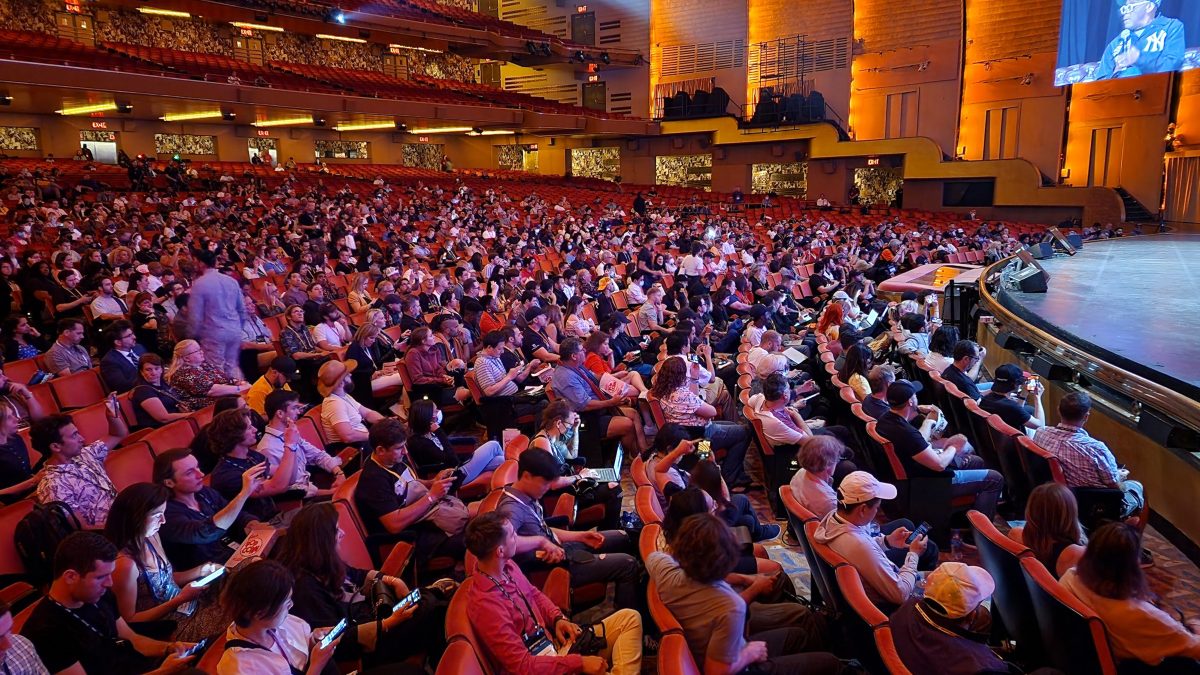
[890,562,1009,675]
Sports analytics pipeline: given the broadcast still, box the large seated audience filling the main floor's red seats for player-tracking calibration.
[0,152,1200,675]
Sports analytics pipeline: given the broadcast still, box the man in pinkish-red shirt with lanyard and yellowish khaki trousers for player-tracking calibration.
[466,512,642,675]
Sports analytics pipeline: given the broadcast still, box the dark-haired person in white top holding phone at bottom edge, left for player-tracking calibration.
[217,560,346,675]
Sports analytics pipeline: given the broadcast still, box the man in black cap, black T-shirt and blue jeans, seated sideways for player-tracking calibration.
[875,380,1004,518]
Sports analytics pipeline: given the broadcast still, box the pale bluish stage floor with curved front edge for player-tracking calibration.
[1001,234,1200,400]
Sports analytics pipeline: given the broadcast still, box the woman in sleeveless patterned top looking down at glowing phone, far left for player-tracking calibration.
[104,483,224,643]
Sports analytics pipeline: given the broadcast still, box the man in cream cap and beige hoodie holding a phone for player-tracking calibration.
[814,471,937,607]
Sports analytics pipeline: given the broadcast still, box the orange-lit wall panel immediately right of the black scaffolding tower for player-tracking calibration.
[850,0,962,155]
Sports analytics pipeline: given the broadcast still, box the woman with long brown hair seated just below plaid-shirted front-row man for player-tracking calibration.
[1008,483,1087,579]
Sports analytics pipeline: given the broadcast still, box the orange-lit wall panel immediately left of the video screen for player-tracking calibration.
[958,0,1067,180]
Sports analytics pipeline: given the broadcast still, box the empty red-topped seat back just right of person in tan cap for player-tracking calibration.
[967,509,1045,663]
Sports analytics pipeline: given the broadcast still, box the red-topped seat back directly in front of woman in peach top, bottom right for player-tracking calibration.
[1021,556,1117,675]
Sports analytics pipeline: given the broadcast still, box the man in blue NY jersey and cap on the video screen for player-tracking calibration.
[1092,0,1186,79]
